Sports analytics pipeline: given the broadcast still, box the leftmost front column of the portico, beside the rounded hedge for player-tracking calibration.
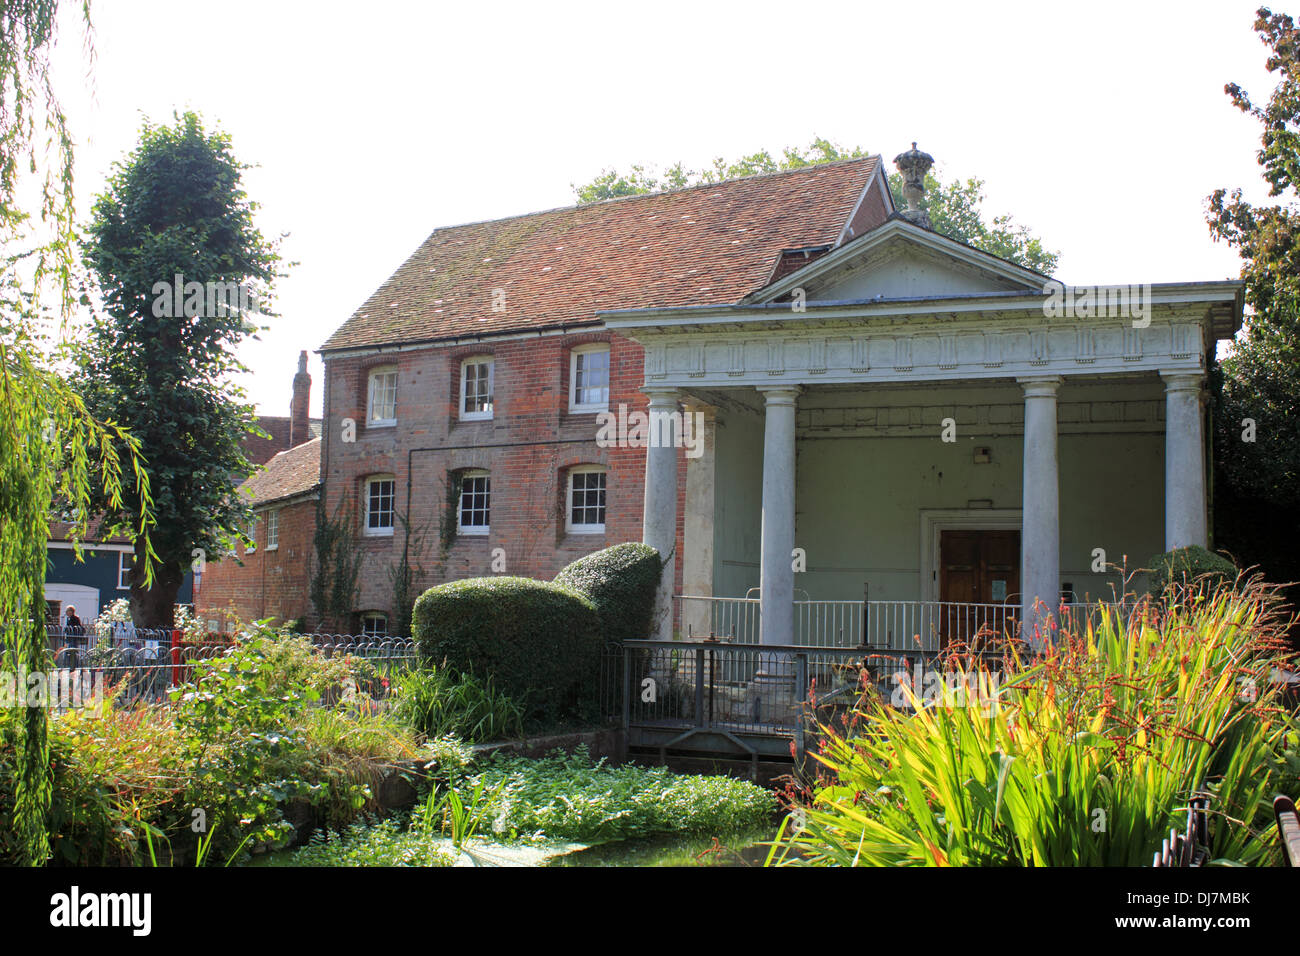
[641,389,679,641]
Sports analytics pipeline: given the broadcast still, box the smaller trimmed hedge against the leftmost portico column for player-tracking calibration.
[555,544,663,643]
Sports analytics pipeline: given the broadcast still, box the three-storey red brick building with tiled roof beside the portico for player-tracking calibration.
[321,157,893,628]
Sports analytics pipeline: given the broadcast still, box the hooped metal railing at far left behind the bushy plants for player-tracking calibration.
[30,626,417,708]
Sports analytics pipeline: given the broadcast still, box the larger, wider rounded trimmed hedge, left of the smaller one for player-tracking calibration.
[411,578,602,719]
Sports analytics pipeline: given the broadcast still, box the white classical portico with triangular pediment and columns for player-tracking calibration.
[603,217,1242,644]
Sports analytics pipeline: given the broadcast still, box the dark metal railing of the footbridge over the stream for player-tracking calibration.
[615,640,1004,752]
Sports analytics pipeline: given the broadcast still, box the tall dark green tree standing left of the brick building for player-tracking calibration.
[78,113,280,627]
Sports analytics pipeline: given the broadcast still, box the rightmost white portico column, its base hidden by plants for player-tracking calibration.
[1160,372,1206,550]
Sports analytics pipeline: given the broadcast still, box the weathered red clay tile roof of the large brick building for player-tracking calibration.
[321,156,878,351]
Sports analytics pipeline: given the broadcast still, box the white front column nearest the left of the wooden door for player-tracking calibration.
[758,385,800,644]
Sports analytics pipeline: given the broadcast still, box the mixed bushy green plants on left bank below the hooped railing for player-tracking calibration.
[0,626,428,866]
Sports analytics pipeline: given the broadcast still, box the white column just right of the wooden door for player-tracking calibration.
[1018,376,1061,648]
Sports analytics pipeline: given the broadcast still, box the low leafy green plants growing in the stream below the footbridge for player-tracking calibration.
[462,747,776,843]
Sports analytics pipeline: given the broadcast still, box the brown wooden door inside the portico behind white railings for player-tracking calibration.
[937,531,1021,646]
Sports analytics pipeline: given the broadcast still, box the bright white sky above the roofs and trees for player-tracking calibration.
[48,0,1274,415]
